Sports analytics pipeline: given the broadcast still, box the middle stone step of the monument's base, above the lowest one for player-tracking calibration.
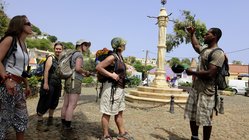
[129,90,188,100]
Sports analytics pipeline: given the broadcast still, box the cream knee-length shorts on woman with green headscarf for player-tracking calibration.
[100,82,125,115]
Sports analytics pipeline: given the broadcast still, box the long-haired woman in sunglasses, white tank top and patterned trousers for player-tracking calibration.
[0,15,32,140]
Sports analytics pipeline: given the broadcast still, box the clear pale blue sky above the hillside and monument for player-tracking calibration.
[5,0,249,64]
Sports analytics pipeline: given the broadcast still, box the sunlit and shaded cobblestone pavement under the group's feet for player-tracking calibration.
[4,88,249,140]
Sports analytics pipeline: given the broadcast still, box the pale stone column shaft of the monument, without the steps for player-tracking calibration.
[151,7,169,88]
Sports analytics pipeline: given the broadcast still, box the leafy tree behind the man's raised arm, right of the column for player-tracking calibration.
[166,10,207,52]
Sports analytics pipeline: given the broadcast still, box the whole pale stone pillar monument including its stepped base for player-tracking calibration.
[125,0,188,104]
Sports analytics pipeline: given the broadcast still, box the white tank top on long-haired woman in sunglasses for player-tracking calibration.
[5,41,29,76]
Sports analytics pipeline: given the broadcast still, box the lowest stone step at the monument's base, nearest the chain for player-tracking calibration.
[125,94,187,104]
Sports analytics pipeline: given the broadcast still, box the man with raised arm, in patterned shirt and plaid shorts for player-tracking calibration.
[184,27,225,140]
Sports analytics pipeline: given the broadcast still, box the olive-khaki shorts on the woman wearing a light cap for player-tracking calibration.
[64,78,82,94]
